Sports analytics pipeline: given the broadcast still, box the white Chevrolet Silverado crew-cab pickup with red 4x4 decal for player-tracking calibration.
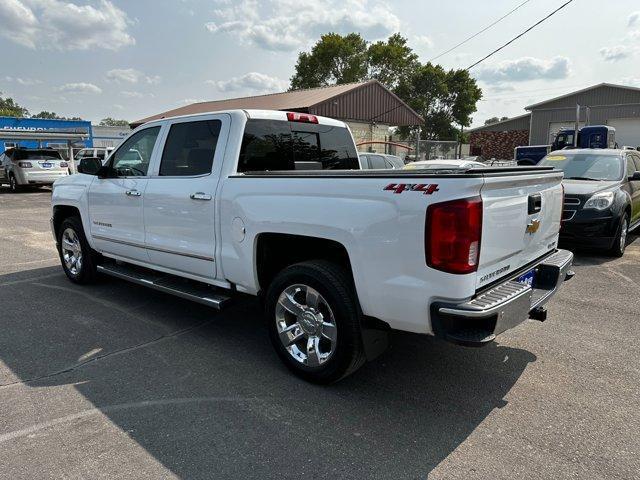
[51,110,573,383]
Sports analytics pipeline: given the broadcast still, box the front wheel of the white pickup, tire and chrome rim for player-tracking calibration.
[57,216,98,285]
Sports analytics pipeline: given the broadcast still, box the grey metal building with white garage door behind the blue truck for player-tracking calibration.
[526,83,640,147]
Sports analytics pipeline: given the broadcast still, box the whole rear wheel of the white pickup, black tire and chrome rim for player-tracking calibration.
[265,260,366,384]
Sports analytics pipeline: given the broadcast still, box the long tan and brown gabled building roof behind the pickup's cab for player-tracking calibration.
[131,80,423,127]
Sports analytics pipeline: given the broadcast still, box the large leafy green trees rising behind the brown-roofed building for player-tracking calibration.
[290,33,482,140]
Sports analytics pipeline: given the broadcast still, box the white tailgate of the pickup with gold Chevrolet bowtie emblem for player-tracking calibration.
[476,172,563,288]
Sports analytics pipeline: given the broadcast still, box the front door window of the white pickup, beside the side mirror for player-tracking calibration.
[111,126,160,177]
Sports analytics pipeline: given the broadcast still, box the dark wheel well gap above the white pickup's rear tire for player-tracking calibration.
[256,233,352,291]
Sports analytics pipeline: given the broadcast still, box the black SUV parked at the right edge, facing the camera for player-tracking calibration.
[540,149,640,257]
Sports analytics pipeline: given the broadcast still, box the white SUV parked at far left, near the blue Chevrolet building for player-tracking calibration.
[0,148,69,192]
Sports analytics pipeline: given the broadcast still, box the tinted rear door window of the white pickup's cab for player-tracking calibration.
[160,120,222,177]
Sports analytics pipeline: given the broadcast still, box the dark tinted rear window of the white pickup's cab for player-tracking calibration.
[238,120,360,172]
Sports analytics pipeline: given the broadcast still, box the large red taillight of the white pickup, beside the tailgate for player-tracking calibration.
[424,197,482,273]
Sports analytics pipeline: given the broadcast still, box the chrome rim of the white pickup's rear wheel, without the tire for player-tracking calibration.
[275,284,338,367]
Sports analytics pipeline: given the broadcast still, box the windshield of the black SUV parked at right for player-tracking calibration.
[540,153,622,180]
